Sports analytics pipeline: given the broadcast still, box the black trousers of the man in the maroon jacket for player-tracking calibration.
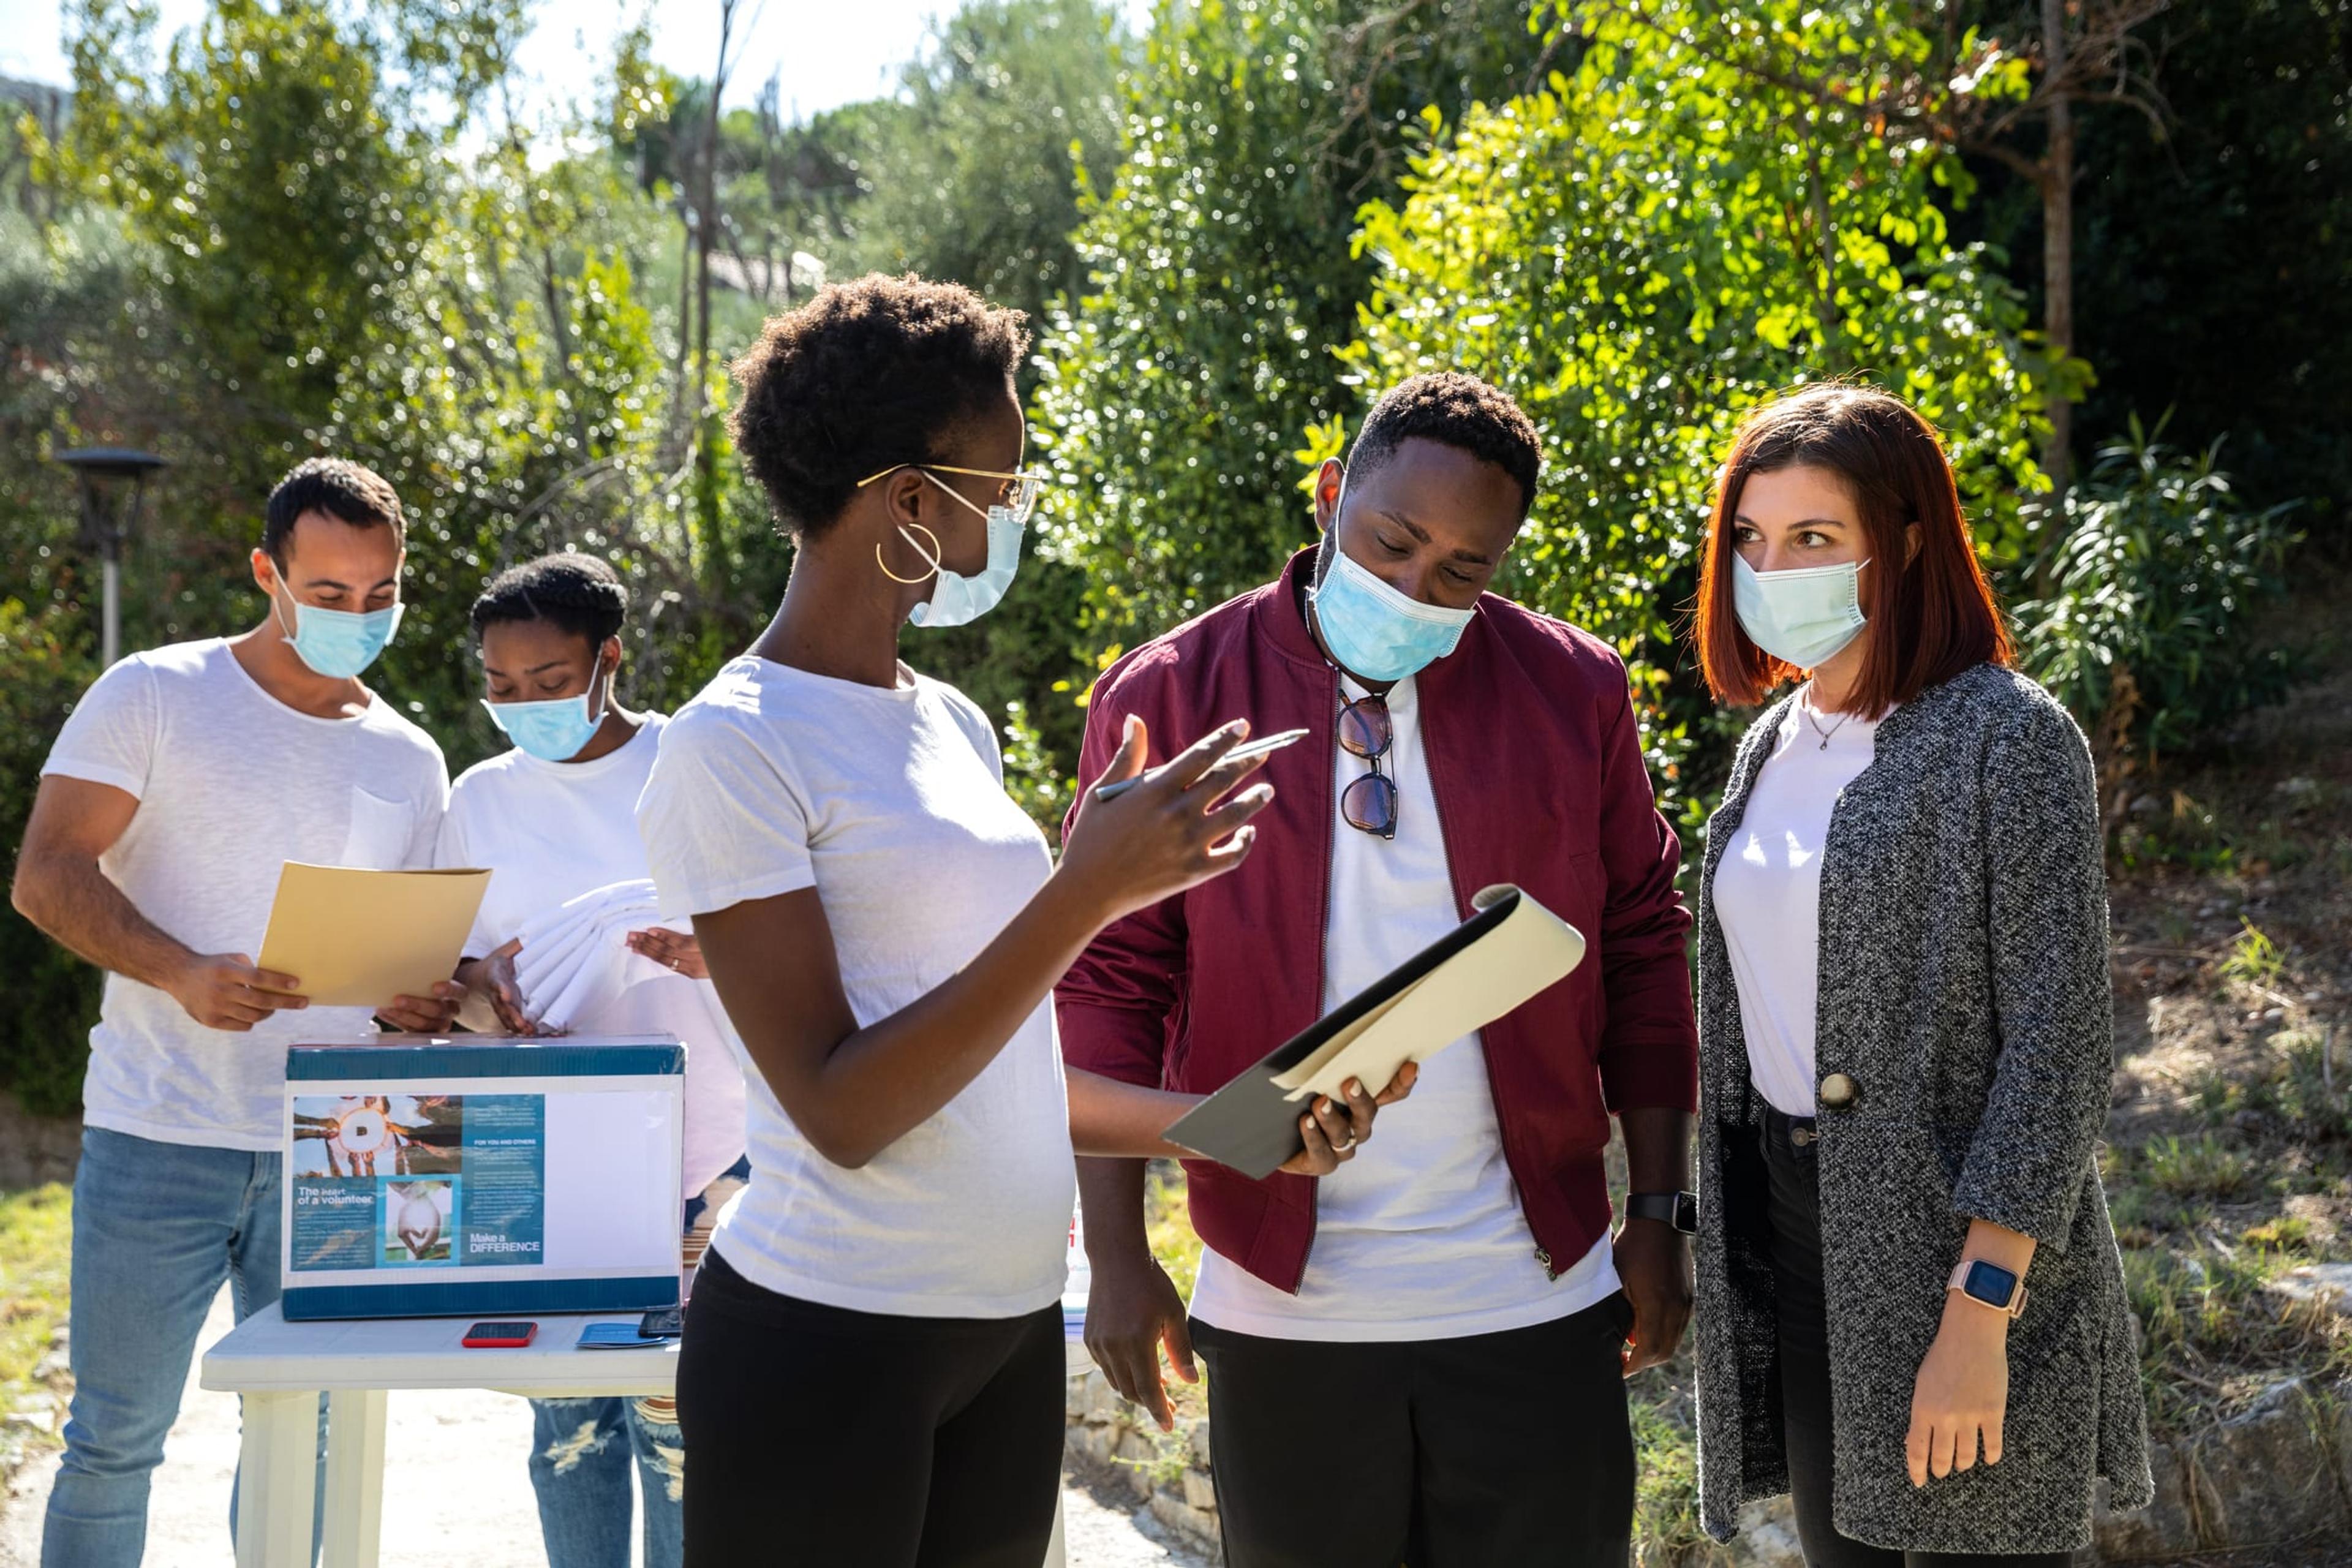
[1193,1295,1632,1568]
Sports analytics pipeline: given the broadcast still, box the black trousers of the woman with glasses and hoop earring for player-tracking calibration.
[677,1253,1063,1568]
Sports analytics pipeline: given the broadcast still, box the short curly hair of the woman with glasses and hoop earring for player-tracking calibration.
[731,273,1028,538]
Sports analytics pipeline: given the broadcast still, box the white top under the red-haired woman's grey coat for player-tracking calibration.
[1714,687,1879,1117]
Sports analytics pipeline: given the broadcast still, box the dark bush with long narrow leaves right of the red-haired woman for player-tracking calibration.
[2016,416,2298,785]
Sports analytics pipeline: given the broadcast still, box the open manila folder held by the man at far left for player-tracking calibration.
[258,861,489,1006]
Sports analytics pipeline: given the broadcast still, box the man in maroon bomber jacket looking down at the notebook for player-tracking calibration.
[1056,374,1696,1568]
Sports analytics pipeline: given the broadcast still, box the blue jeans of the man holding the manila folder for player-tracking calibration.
[40,1126,327,1568]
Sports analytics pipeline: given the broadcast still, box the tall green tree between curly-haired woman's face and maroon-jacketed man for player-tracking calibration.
[1033,0,1538,668]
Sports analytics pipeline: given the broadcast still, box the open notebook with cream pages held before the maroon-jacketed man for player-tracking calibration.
[1164,884,1585,1178]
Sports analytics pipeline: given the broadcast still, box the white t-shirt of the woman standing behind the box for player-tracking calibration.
[433,712,743,1197]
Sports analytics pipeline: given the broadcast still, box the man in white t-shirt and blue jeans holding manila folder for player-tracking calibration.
[12,458,463,1568]
